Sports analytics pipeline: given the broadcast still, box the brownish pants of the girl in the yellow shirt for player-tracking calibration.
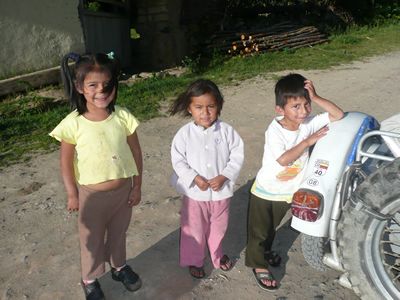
[78,180,132,280]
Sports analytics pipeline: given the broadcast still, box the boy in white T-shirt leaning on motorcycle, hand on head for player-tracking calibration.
[245,74,343,290]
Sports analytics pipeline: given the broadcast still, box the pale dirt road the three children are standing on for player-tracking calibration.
[0,52,400,300]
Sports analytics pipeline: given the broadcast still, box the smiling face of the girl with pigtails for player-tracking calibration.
[77,71,115,112]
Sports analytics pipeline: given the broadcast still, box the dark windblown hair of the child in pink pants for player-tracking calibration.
[169,79,224,117]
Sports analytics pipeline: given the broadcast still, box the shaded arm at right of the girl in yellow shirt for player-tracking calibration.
[127,131,143,206]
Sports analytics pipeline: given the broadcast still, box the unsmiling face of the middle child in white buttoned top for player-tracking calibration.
[188,93,218,128]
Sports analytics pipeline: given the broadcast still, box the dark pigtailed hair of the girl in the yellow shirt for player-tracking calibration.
[61,53,120,115]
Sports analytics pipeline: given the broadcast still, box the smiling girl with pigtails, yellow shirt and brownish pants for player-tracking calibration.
[50,53,142,299]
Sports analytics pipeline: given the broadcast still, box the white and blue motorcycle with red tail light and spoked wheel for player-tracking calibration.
[291,112,400,299]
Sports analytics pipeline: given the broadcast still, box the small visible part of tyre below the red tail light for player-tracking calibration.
[301,234,326,271]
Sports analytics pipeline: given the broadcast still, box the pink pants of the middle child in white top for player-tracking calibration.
[180,196,230,269]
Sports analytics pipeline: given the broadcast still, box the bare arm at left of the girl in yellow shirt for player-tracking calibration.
[60,141,79,211]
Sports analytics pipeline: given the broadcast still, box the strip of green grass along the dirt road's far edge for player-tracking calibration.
[0,22,400,167]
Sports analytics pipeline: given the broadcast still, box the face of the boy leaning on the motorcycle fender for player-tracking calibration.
[275,97,311,130]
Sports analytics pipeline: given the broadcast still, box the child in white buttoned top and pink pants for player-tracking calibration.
[170,79,244,278]
